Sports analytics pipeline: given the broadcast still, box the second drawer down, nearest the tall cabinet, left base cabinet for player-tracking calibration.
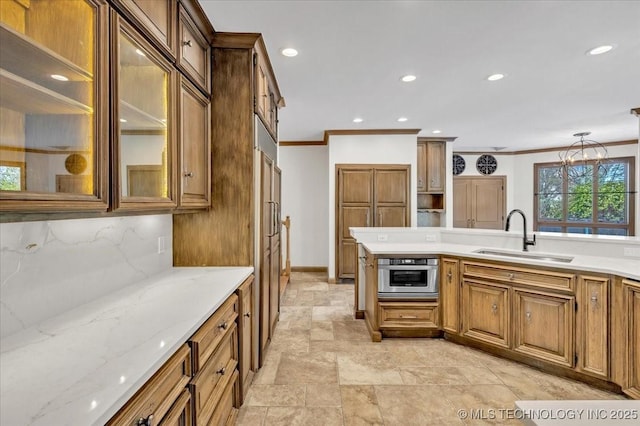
[190,323,238,425]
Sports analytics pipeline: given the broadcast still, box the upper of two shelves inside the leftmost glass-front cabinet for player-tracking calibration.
[0,24,93,81]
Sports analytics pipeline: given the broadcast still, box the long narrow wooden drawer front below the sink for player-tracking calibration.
[462,262,576,291]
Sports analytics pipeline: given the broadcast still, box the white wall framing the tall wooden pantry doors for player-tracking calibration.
[325,135,418,279]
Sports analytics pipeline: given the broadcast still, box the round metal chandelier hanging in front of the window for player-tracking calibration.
[559,132,609,180]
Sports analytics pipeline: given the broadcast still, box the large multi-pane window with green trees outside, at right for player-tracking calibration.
[533,157,635,235]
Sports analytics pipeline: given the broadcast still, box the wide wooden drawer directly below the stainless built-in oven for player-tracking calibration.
[378,302,438,329]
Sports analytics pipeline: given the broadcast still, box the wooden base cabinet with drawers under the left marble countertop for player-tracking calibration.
[107,276,255,426]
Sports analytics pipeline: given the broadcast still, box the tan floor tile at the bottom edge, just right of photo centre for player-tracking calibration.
[340,386,383,426]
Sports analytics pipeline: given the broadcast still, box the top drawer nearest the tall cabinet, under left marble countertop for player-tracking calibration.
[189,294,238,374]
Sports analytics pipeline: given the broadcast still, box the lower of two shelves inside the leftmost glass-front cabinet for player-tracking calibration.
[0,68,93,115]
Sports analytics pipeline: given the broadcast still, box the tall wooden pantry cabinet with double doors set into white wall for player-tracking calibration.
[336,164,410,279]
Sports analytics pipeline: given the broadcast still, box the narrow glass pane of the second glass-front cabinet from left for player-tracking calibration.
[118,25,171,200]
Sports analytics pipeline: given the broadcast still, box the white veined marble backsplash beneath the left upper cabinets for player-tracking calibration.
[0,215,172,337]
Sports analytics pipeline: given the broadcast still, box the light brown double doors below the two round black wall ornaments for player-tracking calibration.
[453,176,505,229]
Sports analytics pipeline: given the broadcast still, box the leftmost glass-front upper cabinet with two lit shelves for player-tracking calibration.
[0,0,109,212]
